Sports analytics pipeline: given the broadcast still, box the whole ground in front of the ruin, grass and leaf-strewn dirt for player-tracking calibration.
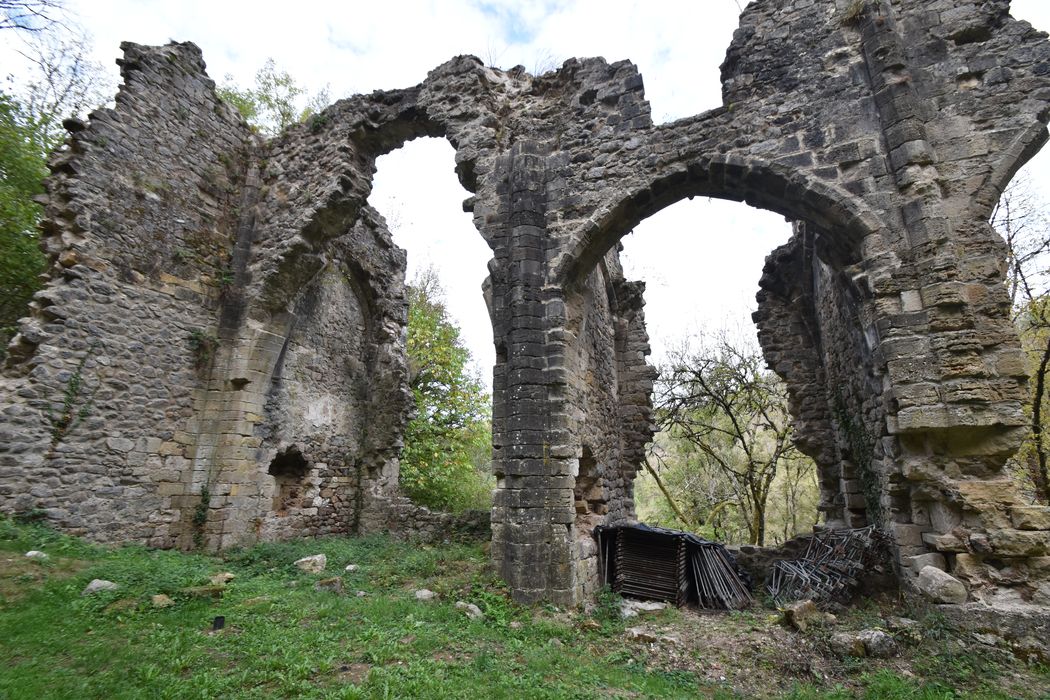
[0,518,1050,699]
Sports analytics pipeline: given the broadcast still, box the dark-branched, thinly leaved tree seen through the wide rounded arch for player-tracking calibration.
[654,333,813,545]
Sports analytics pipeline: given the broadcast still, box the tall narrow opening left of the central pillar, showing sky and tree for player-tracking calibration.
[369,136,495,512]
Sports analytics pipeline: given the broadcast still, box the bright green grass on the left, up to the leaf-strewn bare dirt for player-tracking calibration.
[0,519,700,698]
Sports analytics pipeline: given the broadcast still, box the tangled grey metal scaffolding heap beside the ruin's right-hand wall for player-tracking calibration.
[767,526,890,606]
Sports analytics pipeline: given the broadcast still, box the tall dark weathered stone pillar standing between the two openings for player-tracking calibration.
[492,141,574,603]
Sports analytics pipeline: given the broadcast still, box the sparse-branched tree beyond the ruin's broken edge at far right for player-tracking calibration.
[991,175,1050,503]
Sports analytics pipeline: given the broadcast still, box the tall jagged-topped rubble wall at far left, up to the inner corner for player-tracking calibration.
[0,45,252,546]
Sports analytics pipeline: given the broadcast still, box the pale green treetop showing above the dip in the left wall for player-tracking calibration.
[217,59,329,136]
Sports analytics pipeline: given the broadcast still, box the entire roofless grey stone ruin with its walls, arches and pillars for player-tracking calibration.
[0,0,1050,610]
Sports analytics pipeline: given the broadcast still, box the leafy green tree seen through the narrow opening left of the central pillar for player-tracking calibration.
[400,269,492,511]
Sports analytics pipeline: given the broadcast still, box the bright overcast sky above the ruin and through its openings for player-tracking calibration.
[0,0,1050,388]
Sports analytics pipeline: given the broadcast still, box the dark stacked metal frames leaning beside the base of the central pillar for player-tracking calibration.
[596,525,752,610]
